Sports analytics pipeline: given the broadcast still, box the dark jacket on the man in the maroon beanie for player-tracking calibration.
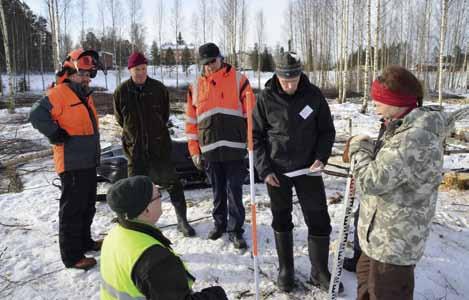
[114,77,171,161]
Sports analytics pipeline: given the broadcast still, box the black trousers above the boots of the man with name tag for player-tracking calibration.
[267,174,331,236]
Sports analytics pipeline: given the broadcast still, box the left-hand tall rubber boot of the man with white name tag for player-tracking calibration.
[274,231,295,292]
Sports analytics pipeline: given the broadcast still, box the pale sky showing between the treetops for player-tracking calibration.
[24,0,288,51]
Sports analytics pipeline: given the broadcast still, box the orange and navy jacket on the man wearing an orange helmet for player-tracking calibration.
[30,83,100,174]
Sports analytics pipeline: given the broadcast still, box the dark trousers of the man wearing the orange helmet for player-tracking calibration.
[59,168,96,267]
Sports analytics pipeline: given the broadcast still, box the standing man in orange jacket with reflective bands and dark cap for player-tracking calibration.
[186,43,254,249]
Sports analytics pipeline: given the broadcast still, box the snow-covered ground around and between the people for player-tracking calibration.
[0,69,469,300]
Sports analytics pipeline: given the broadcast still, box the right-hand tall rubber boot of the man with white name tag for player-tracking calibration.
[308,235,344,293]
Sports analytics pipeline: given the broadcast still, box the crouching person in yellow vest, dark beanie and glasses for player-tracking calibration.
[101,176,228,300]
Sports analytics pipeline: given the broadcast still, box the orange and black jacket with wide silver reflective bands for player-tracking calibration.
[186,64,254,161]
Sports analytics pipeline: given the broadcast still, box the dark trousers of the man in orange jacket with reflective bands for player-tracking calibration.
[205,160,247,233]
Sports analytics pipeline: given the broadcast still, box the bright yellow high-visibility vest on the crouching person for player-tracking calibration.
[100,224,193,300]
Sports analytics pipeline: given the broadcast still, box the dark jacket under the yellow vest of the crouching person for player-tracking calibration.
[120,221,227,300]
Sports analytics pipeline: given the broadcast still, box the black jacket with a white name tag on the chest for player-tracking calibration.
[253,74,335,179]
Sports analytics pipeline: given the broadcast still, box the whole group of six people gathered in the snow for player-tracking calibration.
[26,43,460,300]
